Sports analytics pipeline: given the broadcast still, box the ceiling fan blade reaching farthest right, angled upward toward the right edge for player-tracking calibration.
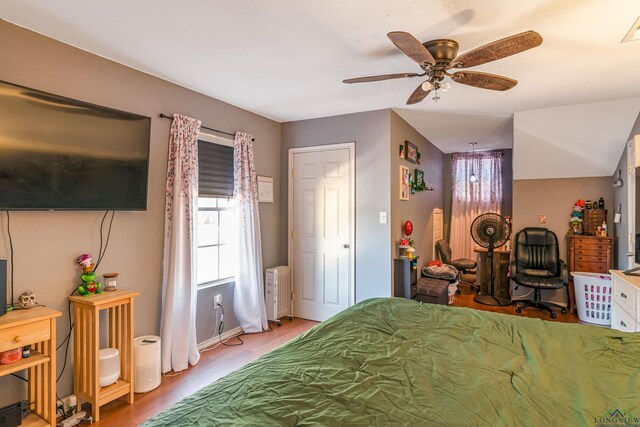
[451,31,542,68]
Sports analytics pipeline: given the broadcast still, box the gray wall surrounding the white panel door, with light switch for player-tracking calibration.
[280,110,392,302]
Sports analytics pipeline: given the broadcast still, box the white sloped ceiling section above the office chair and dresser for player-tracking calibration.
[513,98,640,179]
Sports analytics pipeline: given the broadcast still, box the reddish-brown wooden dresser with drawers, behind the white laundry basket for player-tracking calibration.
[567,234,614,313]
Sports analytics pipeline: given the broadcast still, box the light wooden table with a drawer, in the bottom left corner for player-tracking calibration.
[0,307,61,426]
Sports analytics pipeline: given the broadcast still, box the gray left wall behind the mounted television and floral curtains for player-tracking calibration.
[0,21,282,396]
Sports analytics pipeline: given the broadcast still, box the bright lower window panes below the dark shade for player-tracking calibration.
[197,197,235,286]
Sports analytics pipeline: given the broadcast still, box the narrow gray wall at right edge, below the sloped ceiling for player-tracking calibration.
[611,109,640,269]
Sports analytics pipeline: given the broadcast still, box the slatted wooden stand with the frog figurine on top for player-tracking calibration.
[69,290,140,421]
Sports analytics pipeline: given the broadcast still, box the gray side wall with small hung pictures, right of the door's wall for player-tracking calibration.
[390,111,444,265]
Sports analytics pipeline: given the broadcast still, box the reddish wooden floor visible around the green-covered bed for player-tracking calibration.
[94,285,579,427]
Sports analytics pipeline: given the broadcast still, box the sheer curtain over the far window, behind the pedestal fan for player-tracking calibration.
[449,151,502,259]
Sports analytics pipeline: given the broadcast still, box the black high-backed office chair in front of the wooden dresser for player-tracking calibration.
[511,227,569,319]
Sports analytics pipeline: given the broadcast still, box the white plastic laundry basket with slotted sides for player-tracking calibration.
[571,272,612,326]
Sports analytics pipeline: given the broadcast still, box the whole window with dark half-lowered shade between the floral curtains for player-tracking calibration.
[196,138,235,288]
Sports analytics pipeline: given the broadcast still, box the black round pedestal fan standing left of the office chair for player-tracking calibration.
[471,213,511,305]
